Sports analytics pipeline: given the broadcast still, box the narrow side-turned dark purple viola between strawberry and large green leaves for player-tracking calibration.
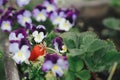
[52,37,67,53]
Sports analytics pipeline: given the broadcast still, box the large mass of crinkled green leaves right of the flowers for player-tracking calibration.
[61,32,120,72]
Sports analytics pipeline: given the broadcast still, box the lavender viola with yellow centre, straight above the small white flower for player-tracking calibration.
[33,6,47,22]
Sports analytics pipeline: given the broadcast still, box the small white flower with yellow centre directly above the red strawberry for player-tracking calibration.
[32,31,45,43]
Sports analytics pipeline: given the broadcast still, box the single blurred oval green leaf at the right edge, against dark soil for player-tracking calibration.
[103,18,120,31]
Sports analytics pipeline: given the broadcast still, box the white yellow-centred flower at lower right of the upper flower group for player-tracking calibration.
[58,20,72,31]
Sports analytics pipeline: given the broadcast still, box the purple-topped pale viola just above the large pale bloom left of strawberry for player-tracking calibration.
[9,28,28,42]
